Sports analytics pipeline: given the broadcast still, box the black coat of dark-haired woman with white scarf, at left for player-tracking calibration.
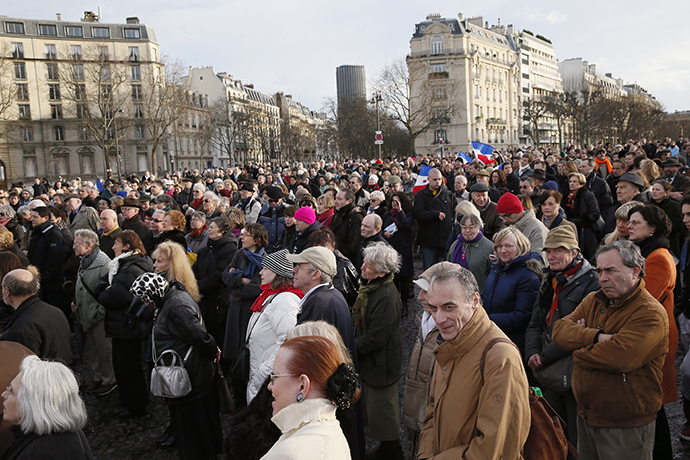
[94,254,153,339]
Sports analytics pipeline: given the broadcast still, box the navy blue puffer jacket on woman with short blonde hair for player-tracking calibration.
[482,252,544,354]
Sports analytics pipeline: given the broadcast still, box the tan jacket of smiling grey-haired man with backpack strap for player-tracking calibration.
[417,307,530,460]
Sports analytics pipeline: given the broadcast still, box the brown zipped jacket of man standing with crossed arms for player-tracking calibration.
[553,280,669,428]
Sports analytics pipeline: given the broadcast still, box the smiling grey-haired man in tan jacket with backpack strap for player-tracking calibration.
[417,265,530,460]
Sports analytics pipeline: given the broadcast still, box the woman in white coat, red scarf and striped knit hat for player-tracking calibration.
[247,249,304,403]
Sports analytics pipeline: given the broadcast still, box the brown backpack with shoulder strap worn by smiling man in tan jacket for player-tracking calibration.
[480,337,579,460]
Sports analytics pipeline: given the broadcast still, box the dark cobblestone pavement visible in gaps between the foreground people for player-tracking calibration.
[76,260,690,460]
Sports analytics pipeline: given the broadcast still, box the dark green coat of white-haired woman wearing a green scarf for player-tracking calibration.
[355,275,402,387]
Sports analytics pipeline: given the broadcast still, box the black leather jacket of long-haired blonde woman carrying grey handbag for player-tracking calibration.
[153,281,218,404]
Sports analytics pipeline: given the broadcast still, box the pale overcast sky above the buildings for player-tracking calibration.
[6,0,690,112]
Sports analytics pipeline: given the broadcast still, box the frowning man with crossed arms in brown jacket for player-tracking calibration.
[553,241,669,460]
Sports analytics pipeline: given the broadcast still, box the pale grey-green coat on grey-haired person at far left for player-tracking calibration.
[74,250,110,331]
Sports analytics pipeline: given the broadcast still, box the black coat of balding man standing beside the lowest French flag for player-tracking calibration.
[414,185,457,248]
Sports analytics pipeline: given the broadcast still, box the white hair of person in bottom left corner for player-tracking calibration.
[17,355,87,436]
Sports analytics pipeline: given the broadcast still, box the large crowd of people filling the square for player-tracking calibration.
[0,135,690,460]
